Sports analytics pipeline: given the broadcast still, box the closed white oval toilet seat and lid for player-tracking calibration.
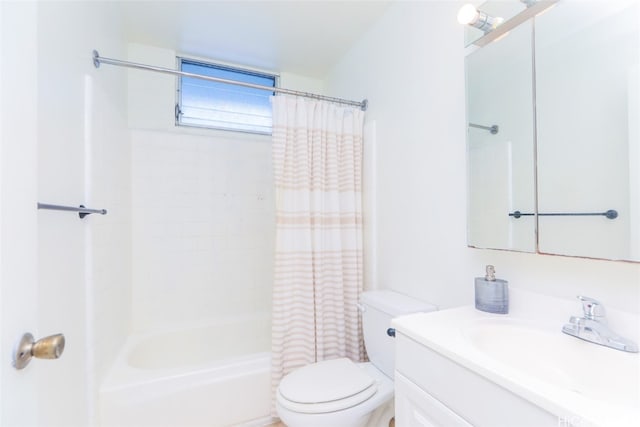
[277,358,378,414]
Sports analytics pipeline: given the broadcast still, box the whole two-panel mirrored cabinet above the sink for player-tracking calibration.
[466,0,640,261]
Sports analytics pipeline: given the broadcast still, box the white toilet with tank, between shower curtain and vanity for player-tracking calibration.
[276,290,437,427]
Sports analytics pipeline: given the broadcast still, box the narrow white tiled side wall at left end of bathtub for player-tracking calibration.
[84,7,132,412]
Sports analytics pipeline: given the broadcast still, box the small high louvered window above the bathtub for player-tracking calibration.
[176,58,276,134]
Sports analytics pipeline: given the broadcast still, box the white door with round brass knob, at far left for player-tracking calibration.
[0,1,38,426]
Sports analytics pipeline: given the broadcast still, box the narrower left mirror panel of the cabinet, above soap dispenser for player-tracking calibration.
[466,21,536,252]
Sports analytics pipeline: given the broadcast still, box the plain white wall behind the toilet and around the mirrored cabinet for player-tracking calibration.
[327,1,640,313]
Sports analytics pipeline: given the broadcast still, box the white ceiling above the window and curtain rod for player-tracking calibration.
[122,0,393,78]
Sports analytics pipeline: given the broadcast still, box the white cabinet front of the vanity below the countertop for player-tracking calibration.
[395,330,556,427]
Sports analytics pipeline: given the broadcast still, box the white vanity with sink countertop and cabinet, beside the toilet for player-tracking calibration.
[392,289,640,427]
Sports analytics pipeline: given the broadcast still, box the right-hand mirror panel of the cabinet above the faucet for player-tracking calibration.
[535,0,640,261]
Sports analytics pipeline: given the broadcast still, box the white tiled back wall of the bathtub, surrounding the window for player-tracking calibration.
[128,44,322,331]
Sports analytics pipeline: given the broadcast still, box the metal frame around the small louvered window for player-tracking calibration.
[174,56,280,135]
